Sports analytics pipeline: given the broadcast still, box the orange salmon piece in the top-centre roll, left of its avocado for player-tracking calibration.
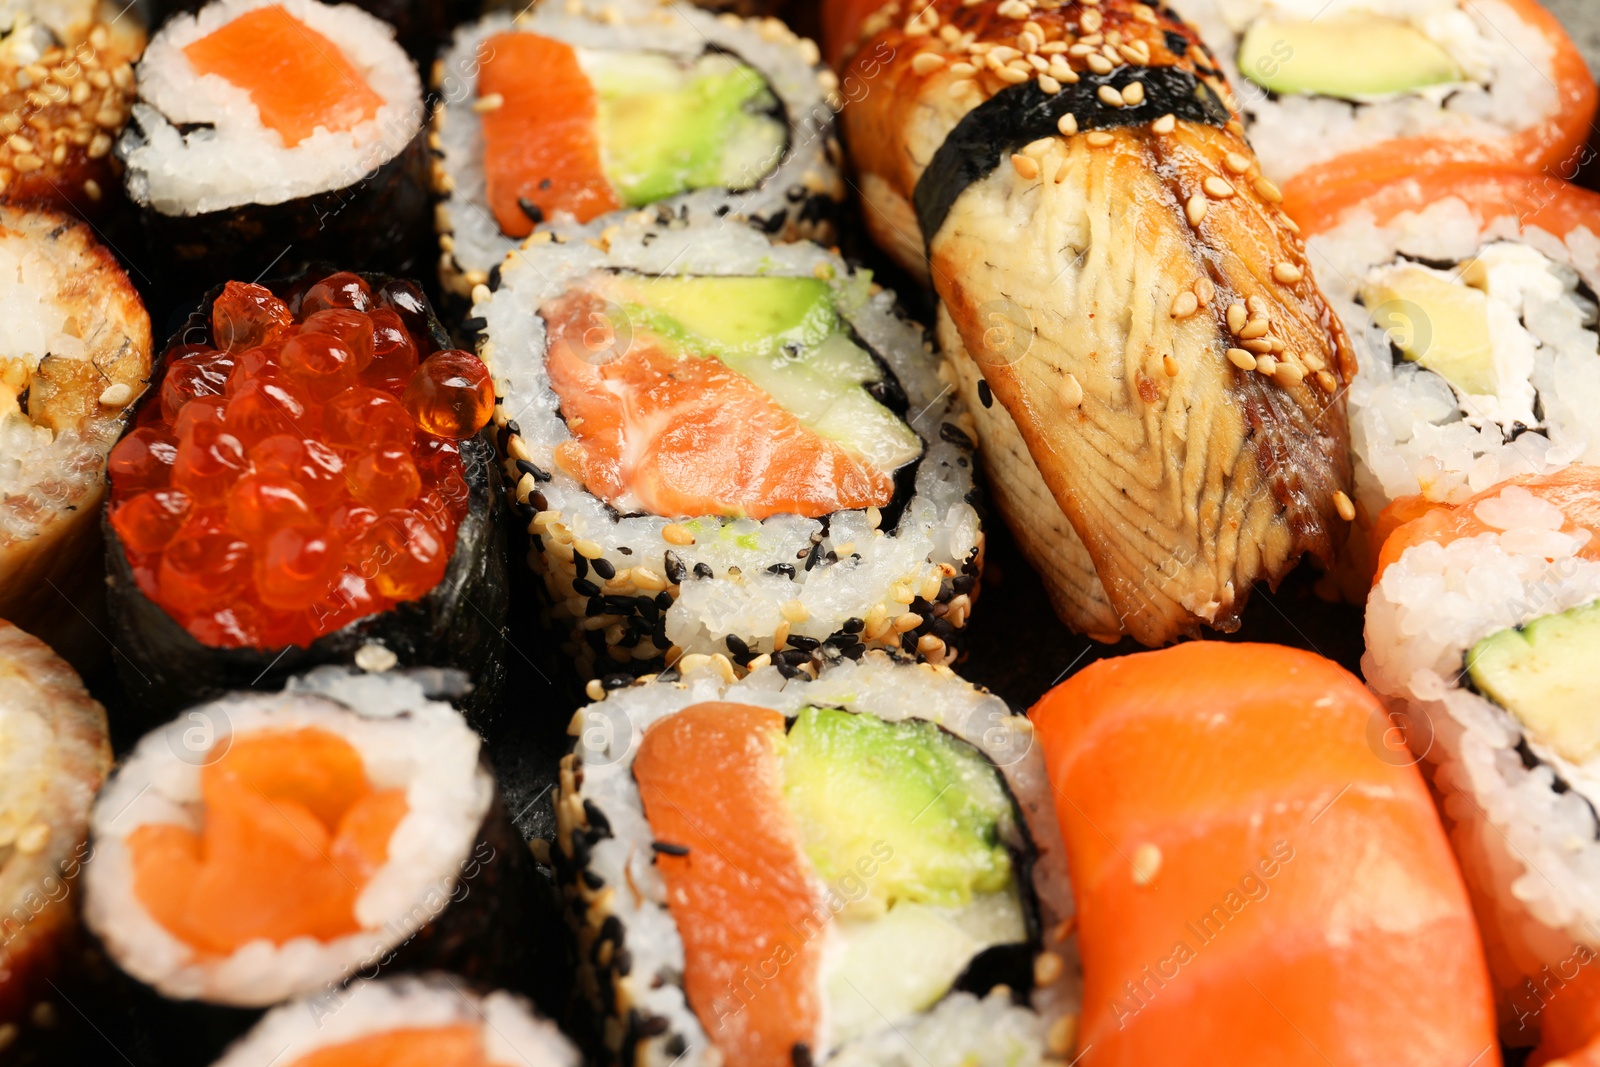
[478,34,621,237]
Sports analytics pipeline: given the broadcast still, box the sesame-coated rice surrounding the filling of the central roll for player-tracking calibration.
[472,211,984,677]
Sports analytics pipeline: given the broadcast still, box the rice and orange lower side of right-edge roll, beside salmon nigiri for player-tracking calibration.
[1362,485,1600,1045]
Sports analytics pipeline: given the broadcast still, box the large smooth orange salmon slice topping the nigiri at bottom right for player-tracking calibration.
[1032,643,1499,1067]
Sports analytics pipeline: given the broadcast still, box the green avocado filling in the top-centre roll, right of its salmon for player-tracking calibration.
[579,50,789,208]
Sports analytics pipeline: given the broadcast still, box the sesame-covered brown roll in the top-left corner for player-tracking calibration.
[0,0,144,218]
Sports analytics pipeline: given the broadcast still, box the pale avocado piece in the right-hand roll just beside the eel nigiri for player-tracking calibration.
[1362,262,1496,397]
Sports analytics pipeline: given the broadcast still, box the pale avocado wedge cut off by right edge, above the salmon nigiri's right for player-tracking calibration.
[1467,603,1600,763]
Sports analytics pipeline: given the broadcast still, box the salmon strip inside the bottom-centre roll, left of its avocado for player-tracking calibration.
[634,702,822,1067]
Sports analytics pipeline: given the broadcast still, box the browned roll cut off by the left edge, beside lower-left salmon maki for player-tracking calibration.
[0,621,110,1054]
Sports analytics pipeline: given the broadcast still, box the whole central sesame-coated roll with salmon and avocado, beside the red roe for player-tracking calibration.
[472,213,982,683]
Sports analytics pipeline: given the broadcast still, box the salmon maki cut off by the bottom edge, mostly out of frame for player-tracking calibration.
[206,974,581,1067]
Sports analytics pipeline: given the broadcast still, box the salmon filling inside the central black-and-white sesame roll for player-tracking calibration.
[541,291,894,518]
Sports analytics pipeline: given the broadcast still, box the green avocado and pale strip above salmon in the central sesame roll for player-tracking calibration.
[606,275,922,472]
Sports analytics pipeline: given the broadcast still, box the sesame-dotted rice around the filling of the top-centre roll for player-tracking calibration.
[429,2,845,294]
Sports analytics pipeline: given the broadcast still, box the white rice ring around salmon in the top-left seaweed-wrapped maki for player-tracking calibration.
[118,0,426,216]
